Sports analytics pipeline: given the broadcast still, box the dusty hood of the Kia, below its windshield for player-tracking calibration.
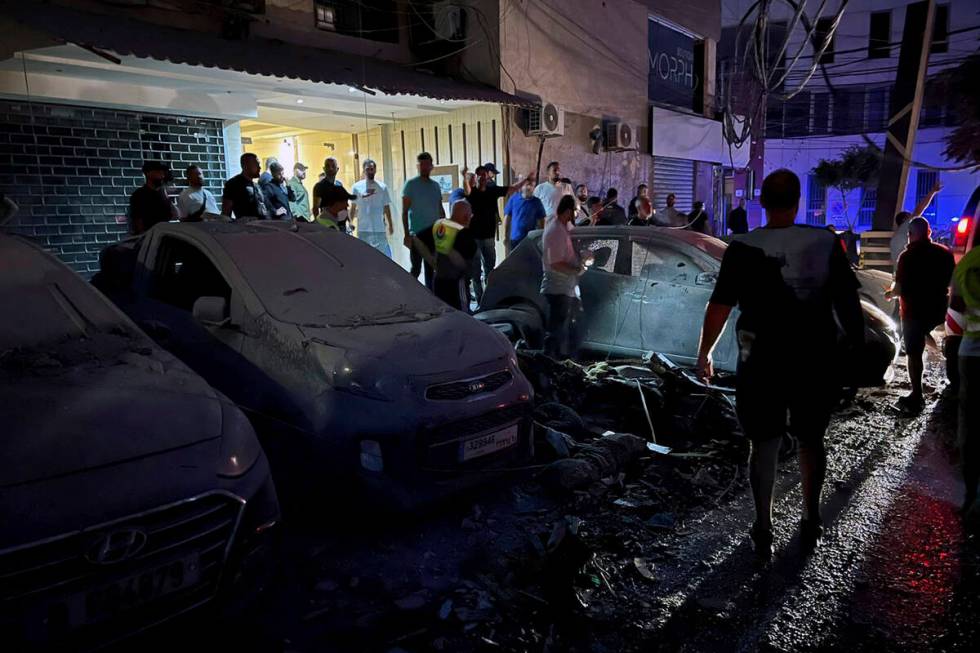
[301,311,512,376]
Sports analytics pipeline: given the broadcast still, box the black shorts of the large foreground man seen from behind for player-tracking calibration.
[735,361,839,444]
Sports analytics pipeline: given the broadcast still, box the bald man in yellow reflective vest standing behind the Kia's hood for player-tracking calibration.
[432,200,476,312]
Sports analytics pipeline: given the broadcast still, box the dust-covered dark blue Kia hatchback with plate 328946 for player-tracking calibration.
[96,221,533,507]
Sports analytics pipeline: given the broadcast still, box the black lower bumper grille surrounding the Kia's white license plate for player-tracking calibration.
[419,403,530,470]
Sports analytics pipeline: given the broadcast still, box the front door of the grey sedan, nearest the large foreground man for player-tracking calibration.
[628,236,733,365]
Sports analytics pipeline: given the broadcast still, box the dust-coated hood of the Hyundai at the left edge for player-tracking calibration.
[0,334,223,487]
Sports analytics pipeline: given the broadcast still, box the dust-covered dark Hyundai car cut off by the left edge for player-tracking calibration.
[0,235,279,651]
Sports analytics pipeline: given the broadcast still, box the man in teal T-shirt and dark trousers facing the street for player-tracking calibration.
[402,152,446,290]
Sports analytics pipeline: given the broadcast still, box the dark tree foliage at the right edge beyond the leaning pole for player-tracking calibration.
[937,53,980,166]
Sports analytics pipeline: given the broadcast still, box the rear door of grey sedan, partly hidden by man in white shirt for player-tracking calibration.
[572,232,629,351]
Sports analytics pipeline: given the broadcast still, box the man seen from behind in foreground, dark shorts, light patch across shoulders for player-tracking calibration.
[697,169,864,558]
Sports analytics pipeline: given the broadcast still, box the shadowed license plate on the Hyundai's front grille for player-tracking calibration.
[67,554,201,627]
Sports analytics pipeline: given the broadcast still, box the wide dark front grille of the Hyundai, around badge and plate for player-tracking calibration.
[0,493,244,649]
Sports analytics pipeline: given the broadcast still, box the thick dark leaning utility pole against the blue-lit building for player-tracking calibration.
[872,0,936,232]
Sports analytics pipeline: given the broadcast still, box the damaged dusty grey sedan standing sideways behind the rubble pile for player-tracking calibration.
[476,227,898,386]
